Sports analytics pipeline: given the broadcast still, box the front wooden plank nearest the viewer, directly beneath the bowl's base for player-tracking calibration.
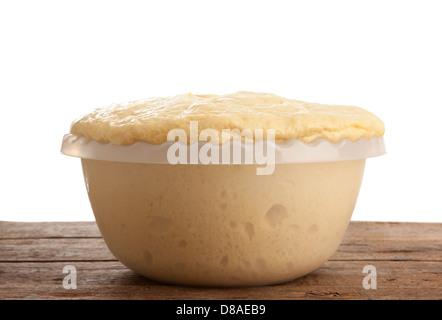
[0,261,442,300]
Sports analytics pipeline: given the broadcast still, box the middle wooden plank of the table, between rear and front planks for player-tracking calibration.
[0,238,442,261]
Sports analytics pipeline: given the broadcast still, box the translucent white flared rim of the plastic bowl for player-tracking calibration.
[61,134,386,165]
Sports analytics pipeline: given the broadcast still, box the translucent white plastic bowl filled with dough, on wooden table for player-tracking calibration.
[62,135,385,286]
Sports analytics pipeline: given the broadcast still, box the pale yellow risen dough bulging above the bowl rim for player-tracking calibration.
[71,91,384,144]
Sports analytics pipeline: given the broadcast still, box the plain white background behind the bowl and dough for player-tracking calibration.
[0,0,442,222]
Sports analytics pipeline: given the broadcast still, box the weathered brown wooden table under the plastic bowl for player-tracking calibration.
[0,222,442,300]
